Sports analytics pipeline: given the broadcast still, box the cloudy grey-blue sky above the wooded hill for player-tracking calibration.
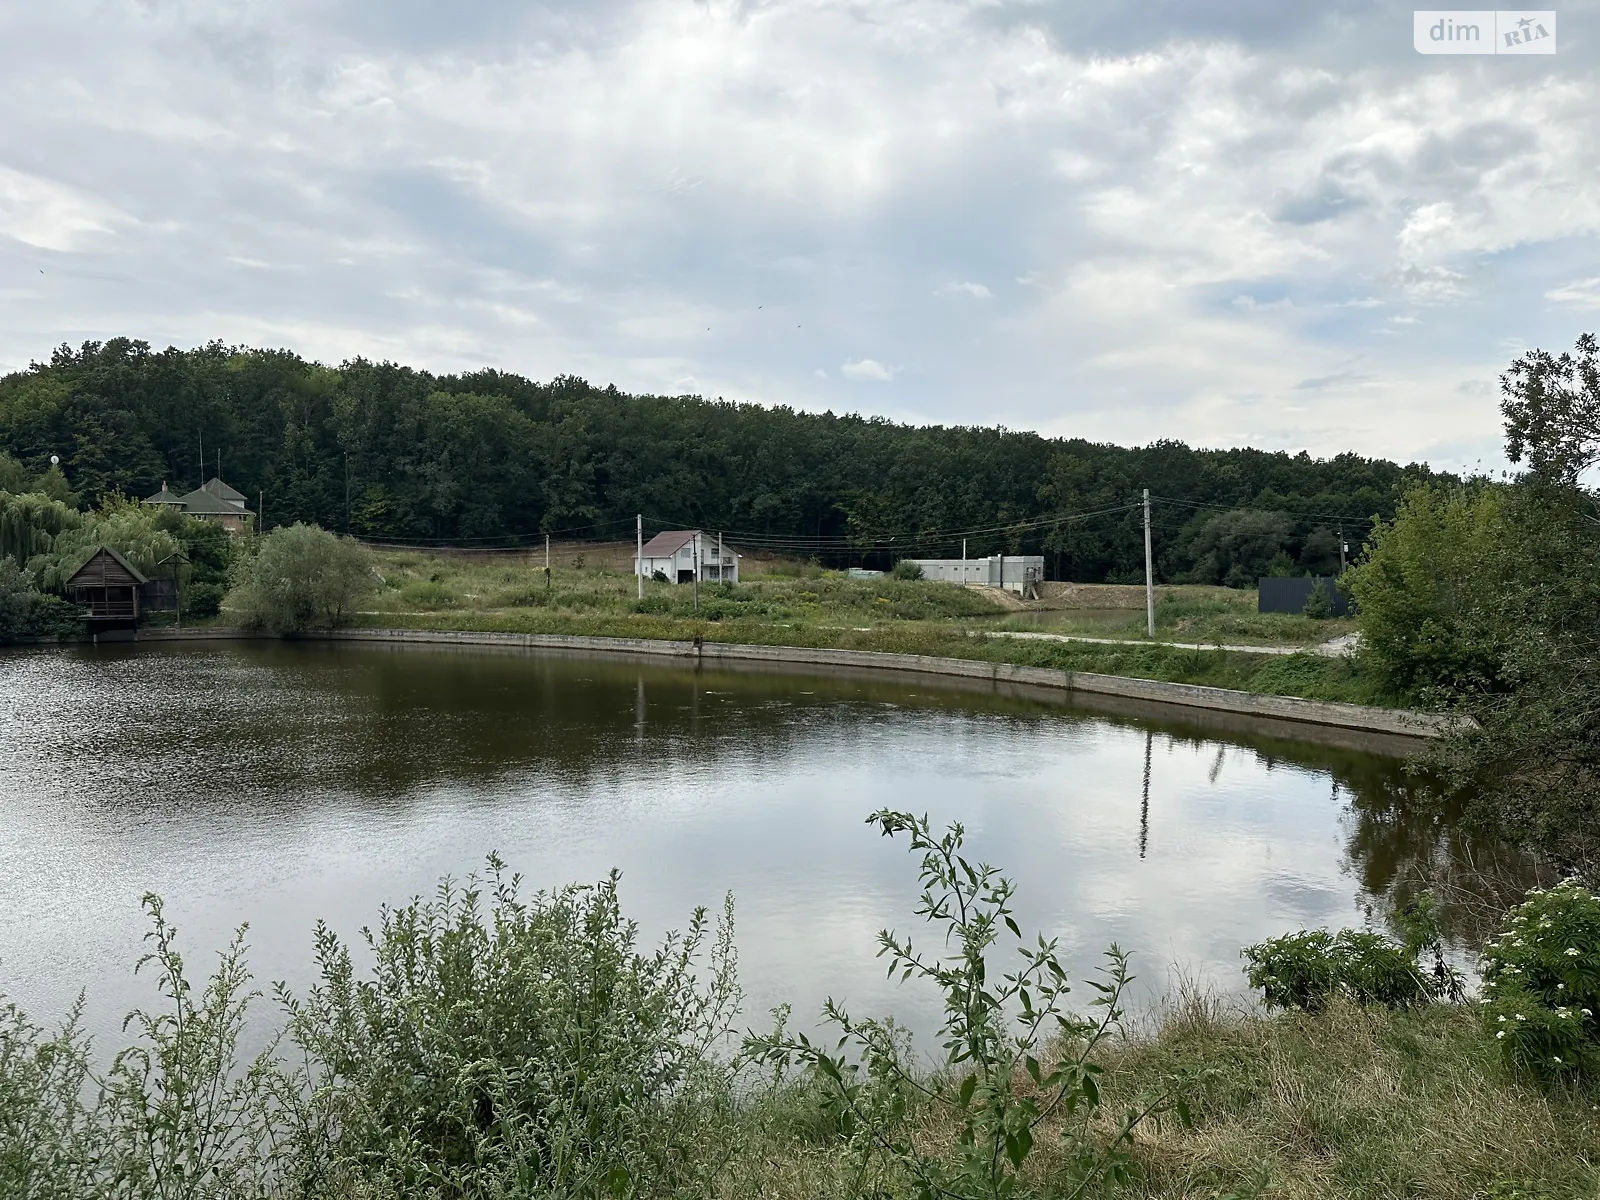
[0,0,1600,467]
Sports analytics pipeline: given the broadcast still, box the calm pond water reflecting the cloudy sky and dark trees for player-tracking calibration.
[0,643,1516,1038]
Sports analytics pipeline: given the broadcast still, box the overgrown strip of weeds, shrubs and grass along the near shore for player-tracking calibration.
[0,811,1600,1200]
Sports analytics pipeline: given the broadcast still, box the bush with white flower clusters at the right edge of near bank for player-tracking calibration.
[1483,880,1600,1077]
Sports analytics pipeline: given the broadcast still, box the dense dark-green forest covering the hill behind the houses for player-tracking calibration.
[0,338,1452,582]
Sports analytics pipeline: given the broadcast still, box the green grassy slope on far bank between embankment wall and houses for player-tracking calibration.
[334,552,1386,704]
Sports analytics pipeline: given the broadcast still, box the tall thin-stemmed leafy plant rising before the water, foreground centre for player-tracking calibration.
[744,810,1190,1200]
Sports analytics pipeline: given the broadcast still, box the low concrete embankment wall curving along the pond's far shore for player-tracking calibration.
[139,629,1461,738]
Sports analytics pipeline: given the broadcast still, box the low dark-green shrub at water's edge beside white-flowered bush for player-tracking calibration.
[1240,930,1461,1013]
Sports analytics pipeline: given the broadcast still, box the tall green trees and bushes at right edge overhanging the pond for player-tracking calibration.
[1349,334,1600,877]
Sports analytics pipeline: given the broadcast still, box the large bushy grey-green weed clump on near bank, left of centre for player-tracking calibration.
[290,856,739,1197]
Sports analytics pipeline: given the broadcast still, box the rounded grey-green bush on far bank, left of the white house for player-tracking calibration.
[234,525,378,634]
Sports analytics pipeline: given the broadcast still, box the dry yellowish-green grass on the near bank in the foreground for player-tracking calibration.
[725,997,1600,1200]
